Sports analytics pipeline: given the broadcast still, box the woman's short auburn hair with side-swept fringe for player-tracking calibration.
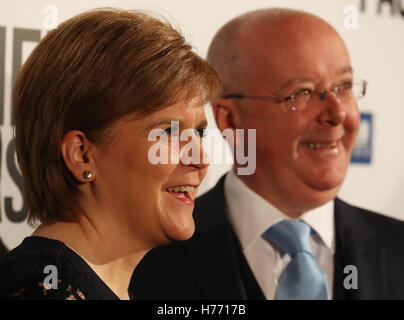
[12,8,220,225]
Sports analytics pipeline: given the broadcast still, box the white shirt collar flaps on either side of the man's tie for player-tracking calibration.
[224,170,335,253]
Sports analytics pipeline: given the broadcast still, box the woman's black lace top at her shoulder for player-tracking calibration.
[0,236,133,300]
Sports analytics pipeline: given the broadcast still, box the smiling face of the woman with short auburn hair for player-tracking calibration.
[94,98,208,247]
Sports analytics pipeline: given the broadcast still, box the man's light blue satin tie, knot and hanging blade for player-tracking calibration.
[262,220,328,300]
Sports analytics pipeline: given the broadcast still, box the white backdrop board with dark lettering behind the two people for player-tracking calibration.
[0,0,404,248]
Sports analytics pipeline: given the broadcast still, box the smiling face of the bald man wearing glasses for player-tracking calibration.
[237,19,360,216]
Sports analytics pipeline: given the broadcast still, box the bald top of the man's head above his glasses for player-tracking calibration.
[210,9,350,91]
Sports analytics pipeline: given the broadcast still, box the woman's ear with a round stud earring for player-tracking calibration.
[60,130,95,183]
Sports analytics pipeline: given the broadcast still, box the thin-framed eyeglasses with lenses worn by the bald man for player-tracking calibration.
[224,80,368,111]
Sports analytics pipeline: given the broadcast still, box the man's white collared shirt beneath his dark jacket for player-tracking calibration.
[224,170,335,300]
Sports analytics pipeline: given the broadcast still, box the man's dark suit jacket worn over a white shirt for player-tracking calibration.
[131,177,404,299]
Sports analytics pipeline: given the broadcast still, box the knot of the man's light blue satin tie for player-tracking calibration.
[262,220,312,257]
